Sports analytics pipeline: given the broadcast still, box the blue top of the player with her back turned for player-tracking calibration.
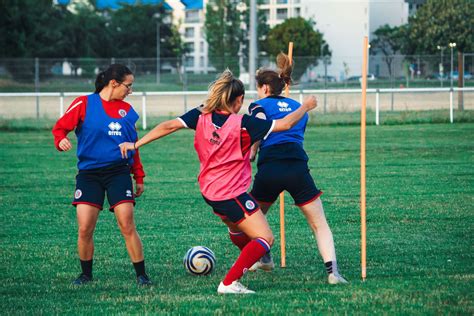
[249,95,309,165]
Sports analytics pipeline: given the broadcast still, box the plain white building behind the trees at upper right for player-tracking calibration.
[302,0,408,80]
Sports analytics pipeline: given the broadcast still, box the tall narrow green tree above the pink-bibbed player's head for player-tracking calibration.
[204,0,243,76]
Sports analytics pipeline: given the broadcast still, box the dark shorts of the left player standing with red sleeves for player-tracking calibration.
[72,164,135,212]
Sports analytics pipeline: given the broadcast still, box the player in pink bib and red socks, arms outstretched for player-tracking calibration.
[120,70,316,294]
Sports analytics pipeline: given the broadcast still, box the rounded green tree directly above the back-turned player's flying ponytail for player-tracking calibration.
[266,17,331,79]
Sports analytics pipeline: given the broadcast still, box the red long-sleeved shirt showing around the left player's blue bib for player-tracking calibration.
[52,95,145,184]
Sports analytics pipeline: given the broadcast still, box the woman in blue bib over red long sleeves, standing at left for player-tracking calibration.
[53,64,151,285]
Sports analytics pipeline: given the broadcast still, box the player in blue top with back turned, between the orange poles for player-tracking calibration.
[249,53,347,284]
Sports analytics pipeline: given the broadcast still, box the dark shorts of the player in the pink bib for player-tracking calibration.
[203,192,260,224]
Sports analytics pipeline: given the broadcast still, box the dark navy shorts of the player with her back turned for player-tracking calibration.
[251,160,322,206]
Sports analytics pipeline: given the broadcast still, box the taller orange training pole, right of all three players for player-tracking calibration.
[360,36,369,281]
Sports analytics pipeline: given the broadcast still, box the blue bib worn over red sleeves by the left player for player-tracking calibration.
[75,93,138,170]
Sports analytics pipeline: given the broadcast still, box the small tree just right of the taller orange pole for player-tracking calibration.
[370,24,404,77]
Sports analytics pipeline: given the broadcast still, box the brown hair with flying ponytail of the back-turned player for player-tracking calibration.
[255,53,293,95]
